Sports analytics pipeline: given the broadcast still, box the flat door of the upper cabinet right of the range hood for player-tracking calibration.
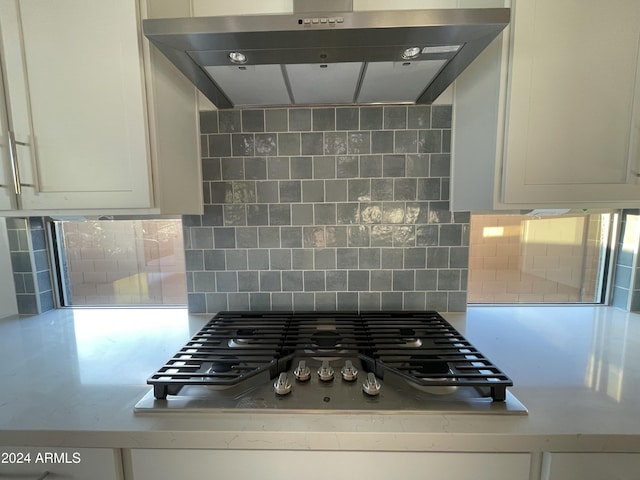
[503,0,640,206]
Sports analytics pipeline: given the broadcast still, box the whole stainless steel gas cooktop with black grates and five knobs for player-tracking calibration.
[135,311,527,414]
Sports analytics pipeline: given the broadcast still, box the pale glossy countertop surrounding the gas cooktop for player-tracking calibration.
[0,306,640,452]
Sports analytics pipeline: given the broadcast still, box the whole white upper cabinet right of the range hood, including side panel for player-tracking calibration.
[452,0,640,210]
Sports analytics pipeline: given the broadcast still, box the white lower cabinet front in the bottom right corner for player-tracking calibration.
[542,453,640,480]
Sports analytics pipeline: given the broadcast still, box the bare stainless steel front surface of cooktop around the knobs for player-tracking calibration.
[135,358,527,415]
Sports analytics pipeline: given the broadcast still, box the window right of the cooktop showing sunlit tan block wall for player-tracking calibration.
[468,213,613,303]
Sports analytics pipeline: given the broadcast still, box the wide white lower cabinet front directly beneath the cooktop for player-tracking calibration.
[126,450,530,480]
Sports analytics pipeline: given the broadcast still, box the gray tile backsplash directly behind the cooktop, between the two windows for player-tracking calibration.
[184,105,469,313]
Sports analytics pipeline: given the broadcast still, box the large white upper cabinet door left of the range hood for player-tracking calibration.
[0,0,150,210]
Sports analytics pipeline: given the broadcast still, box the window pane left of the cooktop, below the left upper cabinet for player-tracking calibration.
[54,219,187,306]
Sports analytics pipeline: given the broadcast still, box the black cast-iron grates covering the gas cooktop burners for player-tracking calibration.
[147,311,513,401]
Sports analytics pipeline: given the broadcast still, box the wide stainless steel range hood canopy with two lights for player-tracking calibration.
[143,2,510,108]
